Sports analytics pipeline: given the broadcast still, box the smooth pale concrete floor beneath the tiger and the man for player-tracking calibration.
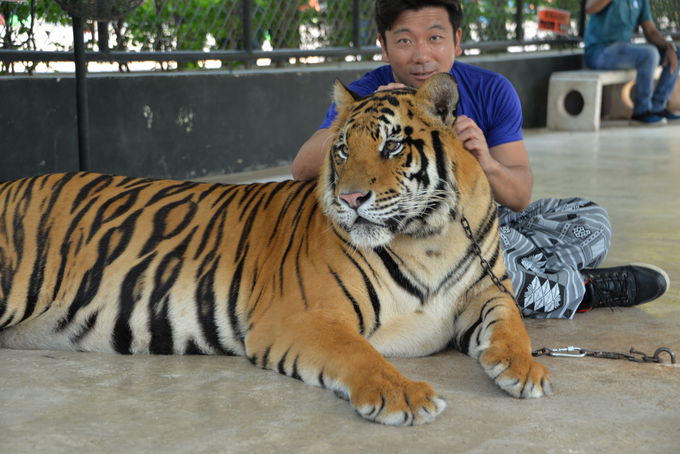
[0,126,680,454]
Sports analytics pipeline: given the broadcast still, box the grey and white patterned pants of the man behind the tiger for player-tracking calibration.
[498,198,612,318]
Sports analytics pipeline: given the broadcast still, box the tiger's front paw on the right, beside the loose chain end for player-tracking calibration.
[480,348,552,399]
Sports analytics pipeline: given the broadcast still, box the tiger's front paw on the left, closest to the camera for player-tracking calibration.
[350,380,446,426]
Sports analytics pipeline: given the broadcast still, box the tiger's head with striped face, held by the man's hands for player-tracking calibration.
[319,73,481,248]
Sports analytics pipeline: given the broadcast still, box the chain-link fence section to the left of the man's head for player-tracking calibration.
[0,0,376,51]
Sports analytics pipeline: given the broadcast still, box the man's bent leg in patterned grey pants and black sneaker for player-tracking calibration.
[499,198,669,318]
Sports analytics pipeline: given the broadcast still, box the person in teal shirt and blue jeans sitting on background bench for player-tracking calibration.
[584,0,680,125]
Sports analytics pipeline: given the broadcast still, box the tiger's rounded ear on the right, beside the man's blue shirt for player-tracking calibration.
[416,73,459,126]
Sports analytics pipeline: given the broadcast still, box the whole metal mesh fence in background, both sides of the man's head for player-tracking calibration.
[0,0,680,73]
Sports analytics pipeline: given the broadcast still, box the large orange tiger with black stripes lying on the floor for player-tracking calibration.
[0,74,551,425]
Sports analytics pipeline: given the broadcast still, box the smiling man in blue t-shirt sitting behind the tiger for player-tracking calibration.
[292,0,668,318]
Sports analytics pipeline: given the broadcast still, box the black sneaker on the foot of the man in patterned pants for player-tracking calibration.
[580,263,670,309]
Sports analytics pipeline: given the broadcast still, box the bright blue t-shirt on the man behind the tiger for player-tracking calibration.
[319,61,522,147]
